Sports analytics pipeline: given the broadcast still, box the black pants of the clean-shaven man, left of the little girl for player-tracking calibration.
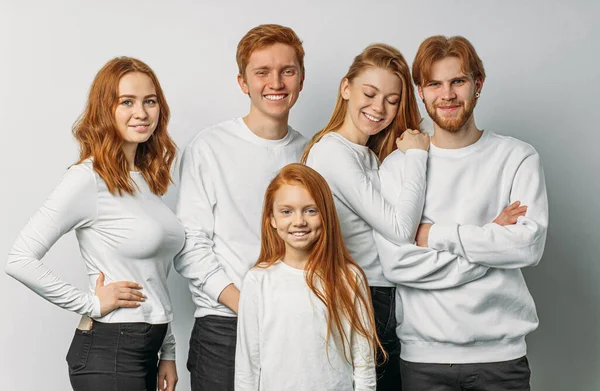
[187,315,237,391]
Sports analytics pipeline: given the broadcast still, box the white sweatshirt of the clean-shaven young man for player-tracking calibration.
[175,118,306,318]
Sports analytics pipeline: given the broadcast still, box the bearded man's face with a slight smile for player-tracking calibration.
[419,57,483,133]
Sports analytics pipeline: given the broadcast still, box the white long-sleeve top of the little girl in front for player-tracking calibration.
[235,261,376,391]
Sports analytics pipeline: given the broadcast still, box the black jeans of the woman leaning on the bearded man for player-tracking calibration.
[370,286,404,391]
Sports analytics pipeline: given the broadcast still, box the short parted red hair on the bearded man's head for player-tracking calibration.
[412,35,485,86]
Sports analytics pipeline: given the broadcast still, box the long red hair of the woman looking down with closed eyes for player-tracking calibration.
[300,43,421,163]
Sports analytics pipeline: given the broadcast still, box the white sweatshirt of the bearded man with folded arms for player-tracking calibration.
[374,131,548,363]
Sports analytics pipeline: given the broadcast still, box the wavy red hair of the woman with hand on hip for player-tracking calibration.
[73,57,176,195]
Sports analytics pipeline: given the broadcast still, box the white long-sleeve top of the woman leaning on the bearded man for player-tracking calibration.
[306,132,427,287]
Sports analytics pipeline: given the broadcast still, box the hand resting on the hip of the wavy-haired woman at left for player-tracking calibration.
[95,273,146,316]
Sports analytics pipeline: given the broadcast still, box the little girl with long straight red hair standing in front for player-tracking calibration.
[235,164,379,391]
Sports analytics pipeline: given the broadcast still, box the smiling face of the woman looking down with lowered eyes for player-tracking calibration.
[339,67,402,145]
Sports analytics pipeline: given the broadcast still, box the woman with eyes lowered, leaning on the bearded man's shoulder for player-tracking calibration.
[302,44,429,391]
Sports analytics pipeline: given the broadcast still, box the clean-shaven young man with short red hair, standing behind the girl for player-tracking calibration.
[175,24,306,391]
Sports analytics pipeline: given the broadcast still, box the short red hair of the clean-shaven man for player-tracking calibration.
[235,24,304,77]
